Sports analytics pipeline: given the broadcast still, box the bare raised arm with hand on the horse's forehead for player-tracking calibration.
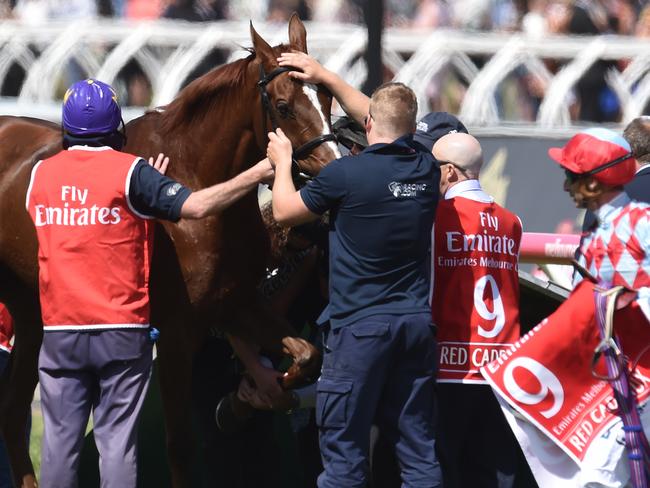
[278,52,370,125]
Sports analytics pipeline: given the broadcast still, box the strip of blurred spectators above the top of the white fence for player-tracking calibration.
[0,0,650,37]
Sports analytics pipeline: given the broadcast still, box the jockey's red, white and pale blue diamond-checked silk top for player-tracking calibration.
[573,193,650,320]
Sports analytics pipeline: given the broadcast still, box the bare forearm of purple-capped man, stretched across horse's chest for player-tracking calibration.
[181,158,273,219]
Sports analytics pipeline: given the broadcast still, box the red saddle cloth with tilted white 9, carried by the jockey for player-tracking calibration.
[481,281,650,466]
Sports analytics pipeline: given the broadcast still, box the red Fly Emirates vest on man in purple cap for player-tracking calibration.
[27,146,151,330]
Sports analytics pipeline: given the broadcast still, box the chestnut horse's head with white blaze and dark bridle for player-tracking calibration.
[251,14,340,179]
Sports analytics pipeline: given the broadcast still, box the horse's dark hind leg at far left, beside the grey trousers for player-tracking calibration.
[0,292,43,488]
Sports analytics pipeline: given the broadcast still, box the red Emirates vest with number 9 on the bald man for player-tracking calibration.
[431,197,521,384]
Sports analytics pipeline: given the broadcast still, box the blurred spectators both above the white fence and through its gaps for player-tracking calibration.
[0,0,650,123]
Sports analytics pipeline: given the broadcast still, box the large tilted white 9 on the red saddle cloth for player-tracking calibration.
[503,357,564,419]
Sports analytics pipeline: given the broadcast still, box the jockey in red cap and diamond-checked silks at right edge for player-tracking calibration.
[549,129,650,302]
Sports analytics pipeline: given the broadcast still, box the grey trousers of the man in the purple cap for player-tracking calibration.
[38,329,152,488]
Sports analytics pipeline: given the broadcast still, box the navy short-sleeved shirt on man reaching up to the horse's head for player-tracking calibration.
[300,136,440,328]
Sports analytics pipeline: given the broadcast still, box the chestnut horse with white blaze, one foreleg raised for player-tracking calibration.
[0,14,338,487]
